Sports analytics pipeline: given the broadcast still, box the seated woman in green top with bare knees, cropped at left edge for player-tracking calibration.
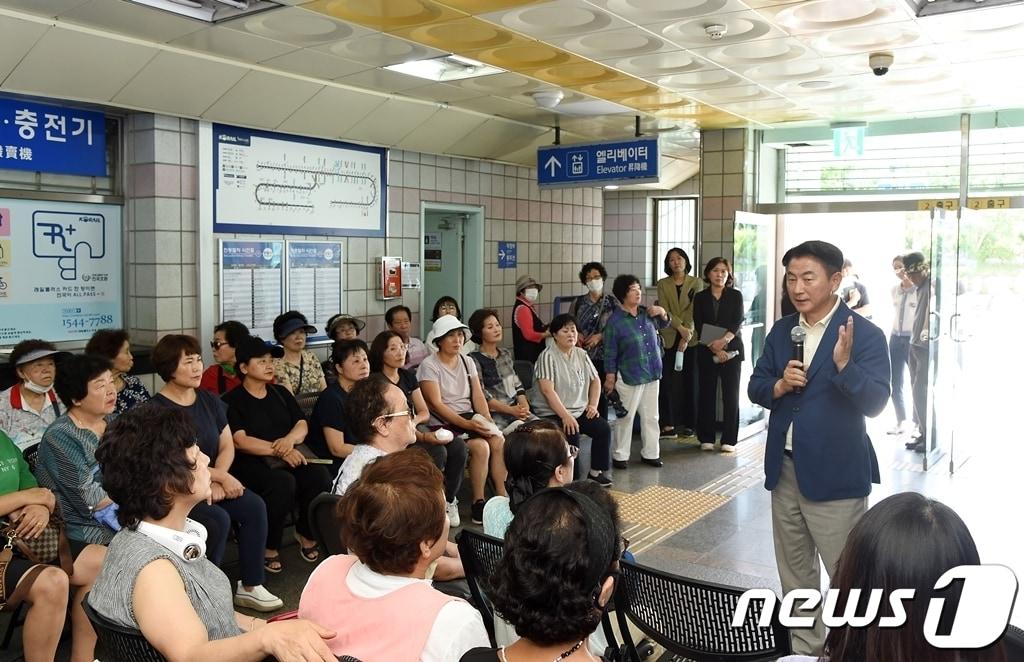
[0,431,105,662]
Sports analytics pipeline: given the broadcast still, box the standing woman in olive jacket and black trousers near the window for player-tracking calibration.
[657,248,703,439]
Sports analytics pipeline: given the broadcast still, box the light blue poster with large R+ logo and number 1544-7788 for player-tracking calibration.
[0,199,124,345]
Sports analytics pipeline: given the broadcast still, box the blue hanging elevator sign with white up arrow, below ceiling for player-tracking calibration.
[537,137,658,187]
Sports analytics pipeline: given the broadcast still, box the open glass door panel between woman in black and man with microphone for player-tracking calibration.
[732,211,776,439]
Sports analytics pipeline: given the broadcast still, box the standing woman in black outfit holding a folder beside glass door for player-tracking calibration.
[693,257,743,453]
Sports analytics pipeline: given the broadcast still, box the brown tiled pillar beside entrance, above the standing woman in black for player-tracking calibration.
[699,129,754,260]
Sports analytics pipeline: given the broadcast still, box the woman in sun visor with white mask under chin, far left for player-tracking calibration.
[0,340,62,461]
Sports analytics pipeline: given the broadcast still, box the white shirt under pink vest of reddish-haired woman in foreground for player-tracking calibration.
[307,561,490,662]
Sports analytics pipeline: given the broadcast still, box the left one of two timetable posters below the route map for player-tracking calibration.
[220,240,285,340]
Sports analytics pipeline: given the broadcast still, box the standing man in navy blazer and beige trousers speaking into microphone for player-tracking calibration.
[748,241,890,656]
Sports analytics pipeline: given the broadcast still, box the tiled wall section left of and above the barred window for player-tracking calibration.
[604,176,699,286]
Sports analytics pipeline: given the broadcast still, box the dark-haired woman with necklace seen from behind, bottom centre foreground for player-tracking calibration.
[462,483,622,662]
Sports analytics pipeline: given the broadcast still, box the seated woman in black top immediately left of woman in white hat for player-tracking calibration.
[370,331,469,527]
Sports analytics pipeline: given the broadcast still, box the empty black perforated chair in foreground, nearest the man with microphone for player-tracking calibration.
[615,561,792,662]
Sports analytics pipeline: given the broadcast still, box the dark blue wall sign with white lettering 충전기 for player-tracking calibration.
[0,97,106,177]
